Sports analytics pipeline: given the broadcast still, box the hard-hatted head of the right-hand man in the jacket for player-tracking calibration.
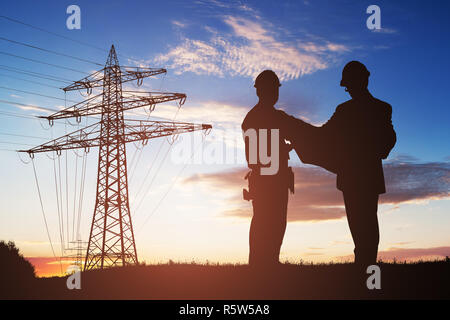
[341,61,370,98]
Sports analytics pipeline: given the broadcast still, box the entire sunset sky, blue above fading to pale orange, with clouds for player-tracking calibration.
[0,0,450,275]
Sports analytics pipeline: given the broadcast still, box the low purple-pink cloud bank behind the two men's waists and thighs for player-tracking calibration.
[184,162,450,221]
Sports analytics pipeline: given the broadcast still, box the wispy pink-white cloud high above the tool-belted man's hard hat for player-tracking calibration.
[154,6,349,81]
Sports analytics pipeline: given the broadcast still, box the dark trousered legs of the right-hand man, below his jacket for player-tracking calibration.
[344,190,380,267]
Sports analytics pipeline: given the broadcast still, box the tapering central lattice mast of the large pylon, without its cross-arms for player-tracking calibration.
[85,47,138,269]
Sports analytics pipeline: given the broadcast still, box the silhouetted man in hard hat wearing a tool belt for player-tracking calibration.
[242,70,294,266]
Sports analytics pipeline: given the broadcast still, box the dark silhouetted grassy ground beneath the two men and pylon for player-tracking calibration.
[3,260,450,300]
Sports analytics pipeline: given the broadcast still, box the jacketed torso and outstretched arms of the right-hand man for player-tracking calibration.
[291,94,396,194]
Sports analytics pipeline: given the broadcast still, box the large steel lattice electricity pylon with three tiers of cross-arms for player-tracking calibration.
[22,45,211,270]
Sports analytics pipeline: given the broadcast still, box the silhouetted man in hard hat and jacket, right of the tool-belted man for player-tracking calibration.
[291,61,396,267]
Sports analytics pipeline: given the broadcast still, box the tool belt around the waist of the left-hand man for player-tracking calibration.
[242,167,294,201]
